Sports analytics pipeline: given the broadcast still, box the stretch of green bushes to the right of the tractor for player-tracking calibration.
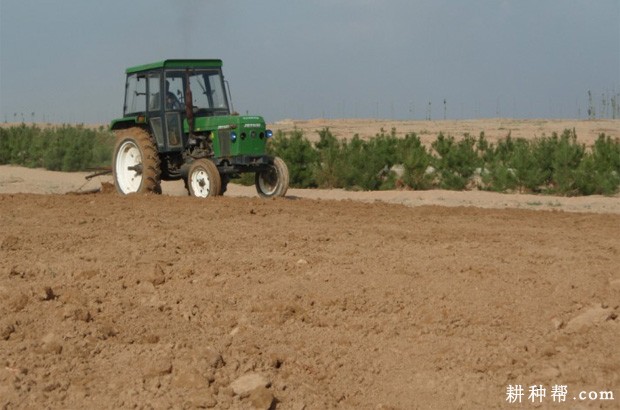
[269,129,620,195]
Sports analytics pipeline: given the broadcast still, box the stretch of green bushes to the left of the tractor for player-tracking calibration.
[0,124,114,171]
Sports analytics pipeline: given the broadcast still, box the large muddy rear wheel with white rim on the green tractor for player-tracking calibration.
[112,127,161,195]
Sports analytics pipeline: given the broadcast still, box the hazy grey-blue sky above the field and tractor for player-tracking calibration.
[0,0,620,123]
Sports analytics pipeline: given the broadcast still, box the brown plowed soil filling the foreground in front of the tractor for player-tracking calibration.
[0,193,620,409]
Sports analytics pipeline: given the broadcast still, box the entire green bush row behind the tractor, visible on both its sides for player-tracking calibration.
[0,124,620,195]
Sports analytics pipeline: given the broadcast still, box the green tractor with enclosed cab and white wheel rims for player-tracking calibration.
[111,60,289,198]
